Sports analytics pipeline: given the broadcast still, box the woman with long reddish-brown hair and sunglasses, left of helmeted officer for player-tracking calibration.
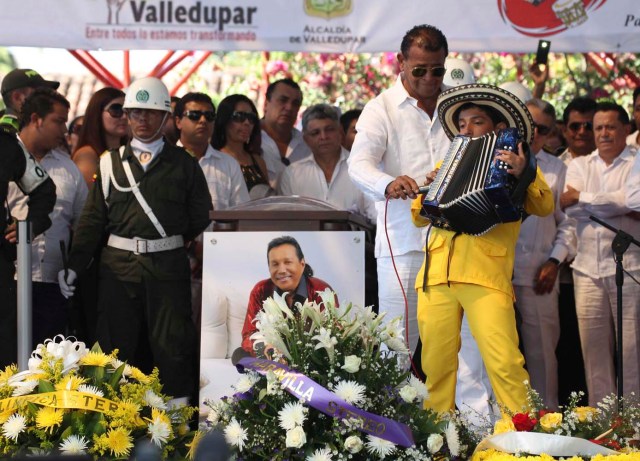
[71,87,129,187]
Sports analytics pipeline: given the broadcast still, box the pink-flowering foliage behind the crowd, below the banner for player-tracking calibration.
[182,51,640,116]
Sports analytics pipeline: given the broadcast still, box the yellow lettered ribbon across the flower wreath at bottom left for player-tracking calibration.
[0,391,146,426]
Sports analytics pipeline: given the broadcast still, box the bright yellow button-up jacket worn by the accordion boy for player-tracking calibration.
[411,168,554,296]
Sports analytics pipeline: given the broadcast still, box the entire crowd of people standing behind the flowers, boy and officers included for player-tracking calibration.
[0,25,640,417]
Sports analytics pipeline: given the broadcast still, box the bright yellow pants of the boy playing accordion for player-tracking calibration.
[418,282,529,413]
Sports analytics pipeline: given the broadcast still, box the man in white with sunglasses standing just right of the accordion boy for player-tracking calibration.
[513,98,575,409]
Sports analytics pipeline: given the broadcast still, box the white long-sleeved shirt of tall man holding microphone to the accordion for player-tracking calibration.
[348,76,451,257]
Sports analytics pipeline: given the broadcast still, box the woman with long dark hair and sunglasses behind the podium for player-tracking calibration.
[211,94,274,199]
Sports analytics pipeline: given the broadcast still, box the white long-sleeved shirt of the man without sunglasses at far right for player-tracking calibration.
[565,146,640,278]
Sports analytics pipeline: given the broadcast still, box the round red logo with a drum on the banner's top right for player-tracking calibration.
[498,0,607,37]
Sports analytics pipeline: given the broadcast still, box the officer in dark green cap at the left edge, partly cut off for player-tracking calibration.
[0,69,59,368]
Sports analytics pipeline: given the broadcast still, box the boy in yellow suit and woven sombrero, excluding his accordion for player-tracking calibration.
[412,84,554,412]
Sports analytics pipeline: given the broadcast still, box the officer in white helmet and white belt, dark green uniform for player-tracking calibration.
[58,77,212,398]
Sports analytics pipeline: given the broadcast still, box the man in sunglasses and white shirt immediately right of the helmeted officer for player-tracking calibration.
[173,93,249,328]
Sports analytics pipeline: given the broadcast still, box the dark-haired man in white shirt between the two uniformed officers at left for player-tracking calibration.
[7,88,88,347]
